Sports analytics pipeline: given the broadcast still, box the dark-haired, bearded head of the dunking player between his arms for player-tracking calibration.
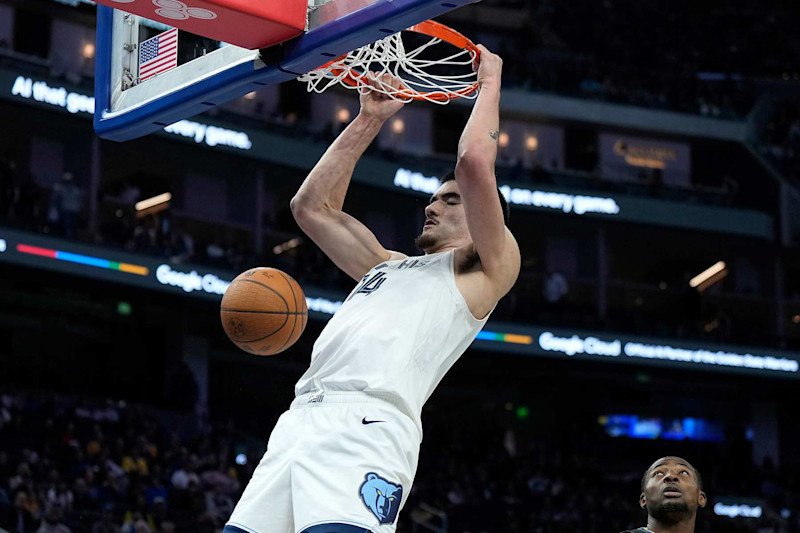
[415,171,510,253]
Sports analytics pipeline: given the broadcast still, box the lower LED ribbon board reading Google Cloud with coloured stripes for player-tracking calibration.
[0,227,800,379]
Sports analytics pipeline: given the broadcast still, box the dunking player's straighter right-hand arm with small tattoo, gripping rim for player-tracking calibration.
[455,45,520,297]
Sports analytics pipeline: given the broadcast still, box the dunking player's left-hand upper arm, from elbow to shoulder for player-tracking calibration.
[292,206,405,281]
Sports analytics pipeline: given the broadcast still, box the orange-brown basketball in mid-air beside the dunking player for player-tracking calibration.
[220,267,308,355]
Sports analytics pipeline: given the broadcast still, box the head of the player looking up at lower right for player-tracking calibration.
[639,456,706,525]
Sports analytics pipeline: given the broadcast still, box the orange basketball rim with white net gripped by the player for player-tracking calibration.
[297,20,480,104]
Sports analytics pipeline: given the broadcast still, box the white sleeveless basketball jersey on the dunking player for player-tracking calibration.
[295,250,488,432]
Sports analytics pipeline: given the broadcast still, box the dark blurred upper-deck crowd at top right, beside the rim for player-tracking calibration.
[468,0,800,118]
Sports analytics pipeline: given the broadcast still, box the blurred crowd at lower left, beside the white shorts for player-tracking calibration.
[0,388,251,533]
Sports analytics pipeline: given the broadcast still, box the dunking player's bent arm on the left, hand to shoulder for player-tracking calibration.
[291,76,404,280]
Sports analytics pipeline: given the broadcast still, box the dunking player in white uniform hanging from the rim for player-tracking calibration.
[224,47,520,533]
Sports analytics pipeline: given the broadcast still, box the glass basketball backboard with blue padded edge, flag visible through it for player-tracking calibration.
[94,0,477,141]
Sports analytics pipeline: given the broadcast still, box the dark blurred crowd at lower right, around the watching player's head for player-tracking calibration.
[407,406,800,533]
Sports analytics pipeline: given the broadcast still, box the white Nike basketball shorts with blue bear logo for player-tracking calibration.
[223,391,421,533]
